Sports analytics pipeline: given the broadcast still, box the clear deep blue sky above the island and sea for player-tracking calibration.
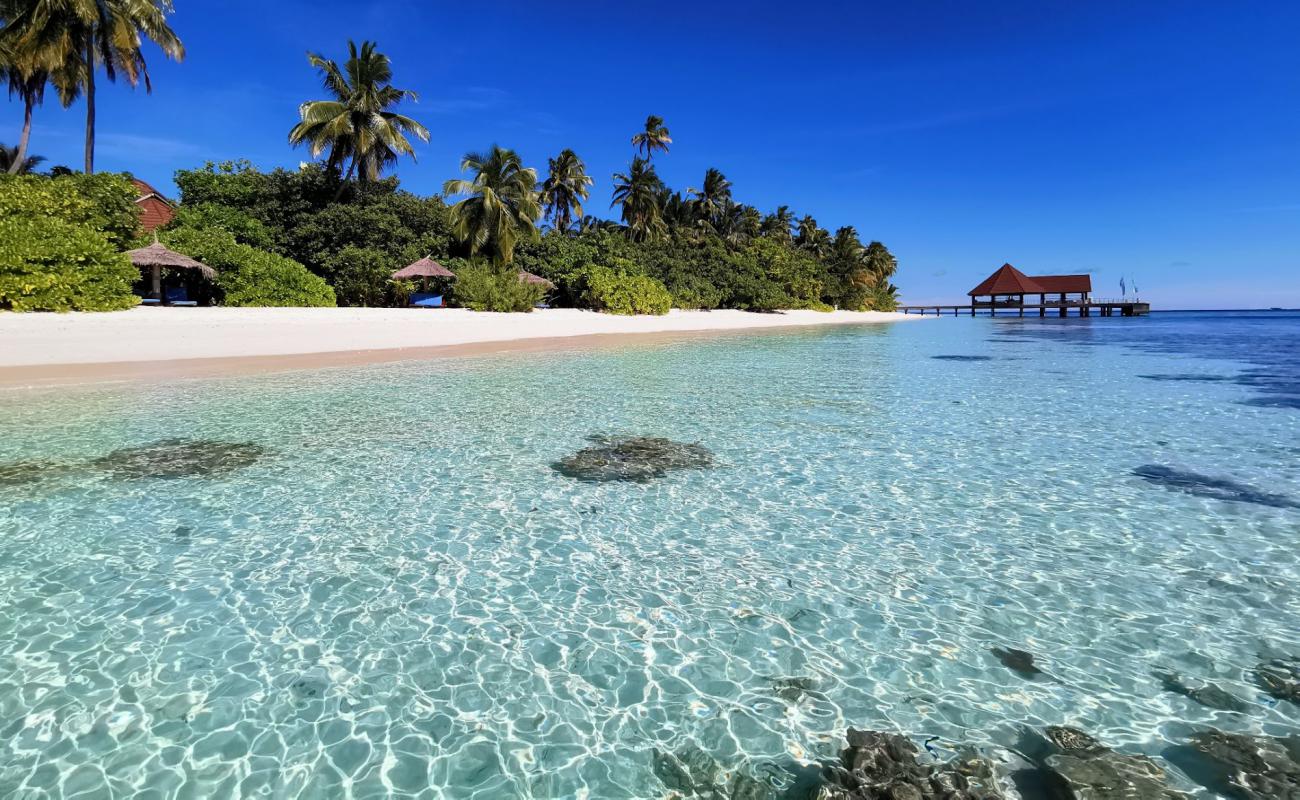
[10,0,1300,308]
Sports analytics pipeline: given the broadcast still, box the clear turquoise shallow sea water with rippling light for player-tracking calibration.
[0,313,1300,799]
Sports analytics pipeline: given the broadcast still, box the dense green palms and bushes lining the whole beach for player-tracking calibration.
[0,11,897,313]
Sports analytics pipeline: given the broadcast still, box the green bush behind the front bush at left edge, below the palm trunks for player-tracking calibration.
[0,173,140,250]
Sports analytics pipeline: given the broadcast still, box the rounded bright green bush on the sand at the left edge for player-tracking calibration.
[0,217,140,311]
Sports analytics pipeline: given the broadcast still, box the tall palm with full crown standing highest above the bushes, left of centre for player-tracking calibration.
[289,40,429,194]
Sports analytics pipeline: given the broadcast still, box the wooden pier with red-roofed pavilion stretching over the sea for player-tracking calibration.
[898,264,1151,316]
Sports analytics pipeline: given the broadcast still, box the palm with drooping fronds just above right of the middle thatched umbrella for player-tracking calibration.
[442,144,542,267]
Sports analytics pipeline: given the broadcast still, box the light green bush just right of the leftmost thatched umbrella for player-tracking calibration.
[163,228,337,313]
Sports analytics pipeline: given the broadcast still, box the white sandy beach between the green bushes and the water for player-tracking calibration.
[0,308,919,386]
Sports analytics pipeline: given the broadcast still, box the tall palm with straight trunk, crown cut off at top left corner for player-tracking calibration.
[5,0,185,173]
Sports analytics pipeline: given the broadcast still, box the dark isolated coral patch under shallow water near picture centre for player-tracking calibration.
[551,436,714,483]
